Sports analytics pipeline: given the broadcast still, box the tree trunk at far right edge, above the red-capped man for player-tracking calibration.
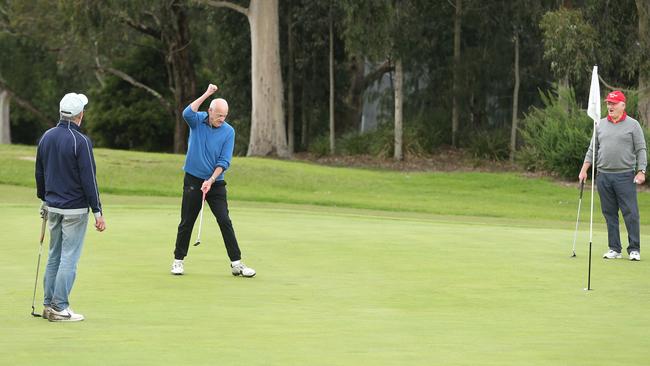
[636,0,650,127]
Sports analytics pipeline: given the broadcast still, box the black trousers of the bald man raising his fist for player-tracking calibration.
[174,173,241,261]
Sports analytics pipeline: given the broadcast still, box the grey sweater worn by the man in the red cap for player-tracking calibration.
[585,116,648,173]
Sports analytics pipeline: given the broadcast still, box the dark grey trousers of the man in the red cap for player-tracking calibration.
[596,171,641,253]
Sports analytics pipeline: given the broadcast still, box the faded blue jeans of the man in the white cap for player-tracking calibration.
[43,212,88,311]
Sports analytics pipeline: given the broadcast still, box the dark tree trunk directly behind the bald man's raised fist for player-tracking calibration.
[163,0,196,153]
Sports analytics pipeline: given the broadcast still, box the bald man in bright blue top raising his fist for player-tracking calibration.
[171,84,255,277]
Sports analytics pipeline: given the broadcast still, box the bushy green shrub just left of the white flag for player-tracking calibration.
[519,87,593,179]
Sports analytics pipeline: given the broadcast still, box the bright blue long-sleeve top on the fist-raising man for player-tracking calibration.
[183,105,235,180]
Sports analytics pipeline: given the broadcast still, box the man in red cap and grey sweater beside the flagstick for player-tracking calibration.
[578,91,648,261]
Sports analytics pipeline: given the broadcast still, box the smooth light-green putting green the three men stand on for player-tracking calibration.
[0,186,650,365]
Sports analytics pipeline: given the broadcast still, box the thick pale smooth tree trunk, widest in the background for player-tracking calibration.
[247,0,290,157]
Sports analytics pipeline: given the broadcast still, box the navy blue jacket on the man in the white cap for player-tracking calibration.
[36,121,102,215]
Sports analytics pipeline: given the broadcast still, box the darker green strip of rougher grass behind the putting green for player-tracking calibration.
[0,145,636,224]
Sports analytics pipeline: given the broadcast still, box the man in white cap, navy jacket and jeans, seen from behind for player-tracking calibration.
[36,93,106,321]
